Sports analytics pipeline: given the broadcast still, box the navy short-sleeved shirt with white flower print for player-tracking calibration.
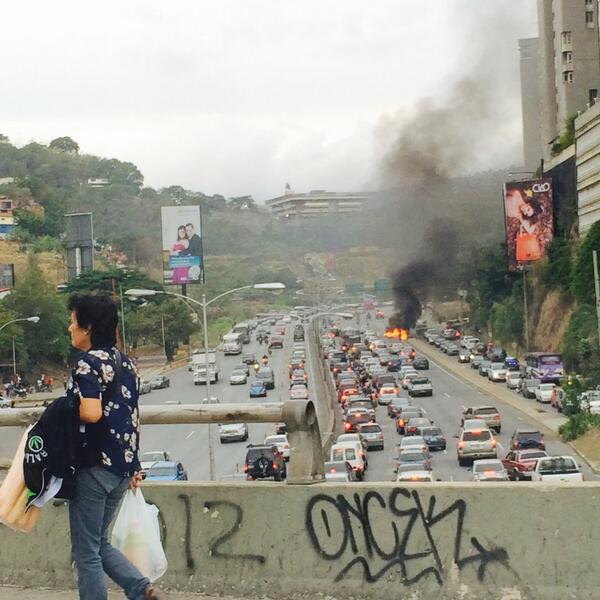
[67,348,140,477]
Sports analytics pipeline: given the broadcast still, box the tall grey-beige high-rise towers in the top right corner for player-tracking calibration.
[519,0,600,164]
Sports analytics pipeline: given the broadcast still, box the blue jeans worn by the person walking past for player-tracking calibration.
[69,467,150,600]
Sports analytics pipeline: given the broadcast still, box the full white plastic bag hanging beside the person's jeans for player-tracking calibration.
[112,489,167,581]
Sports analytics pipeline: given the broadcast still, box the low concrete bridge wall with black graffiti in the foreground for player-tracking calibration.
[0,482,600,600]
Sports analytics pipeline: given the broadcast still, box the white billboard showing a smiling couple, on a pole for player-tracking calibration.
[160,206,204,285]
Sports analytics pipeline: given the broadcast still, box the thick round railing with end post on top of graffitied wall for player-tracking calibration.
[0,400,325,484]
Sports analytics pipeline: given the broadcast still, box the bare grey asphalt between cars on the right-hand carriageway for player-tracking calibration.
[337,320,599,485]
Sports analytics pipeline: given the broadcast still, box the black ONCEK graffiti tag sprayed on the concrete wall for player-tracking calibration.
[306,488,508,585]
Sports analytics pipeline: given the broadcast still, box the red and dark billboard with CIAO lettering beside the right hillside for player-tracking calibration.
[504,178,554,271]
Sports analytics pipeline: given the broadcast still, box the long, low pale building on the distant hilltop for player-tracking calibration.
[266,187,375,219]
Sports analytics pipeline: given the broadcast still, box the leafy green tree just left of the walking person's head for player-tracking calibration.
[1,255,70,370]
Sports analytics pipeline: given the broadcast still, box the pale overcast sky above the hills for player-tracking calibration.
[0,0,537,202]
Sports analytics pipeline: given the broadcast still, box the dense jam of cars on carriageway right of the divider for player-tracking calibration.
[320,312,583,482]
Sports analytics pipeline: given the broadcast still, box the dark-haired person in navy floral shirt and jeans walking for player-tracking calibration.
[67,296,160,600]
